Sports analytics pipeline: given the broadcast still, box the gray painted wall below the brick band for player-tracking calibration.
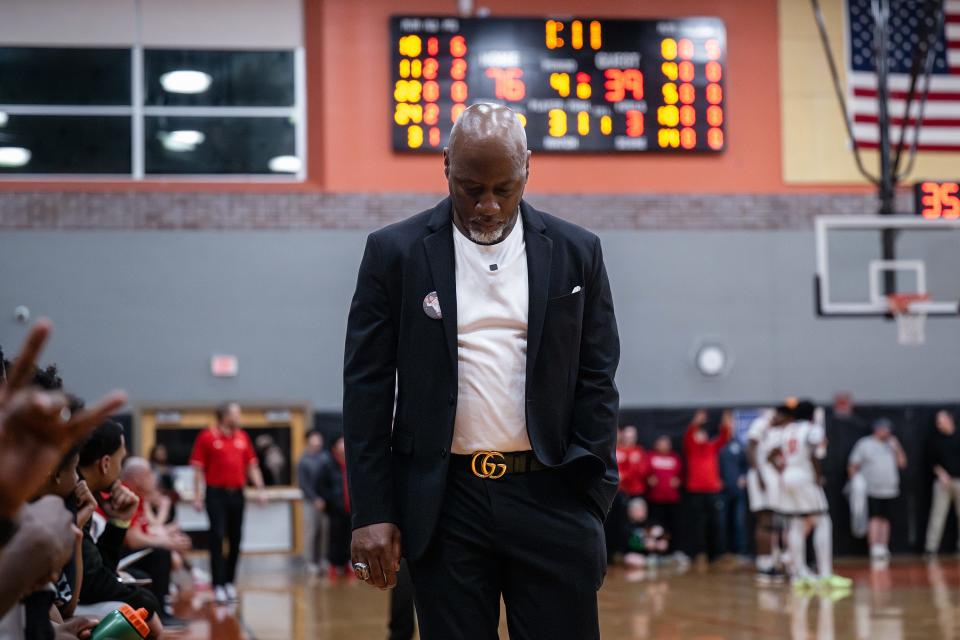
[0,231,960,410]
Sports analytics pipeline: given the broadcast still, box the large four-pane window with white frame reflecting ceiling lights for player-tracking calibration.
[0,47,305,180]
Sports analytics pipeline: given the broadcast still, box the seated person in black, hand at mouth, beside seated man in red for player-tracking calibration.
[79,420,165,637]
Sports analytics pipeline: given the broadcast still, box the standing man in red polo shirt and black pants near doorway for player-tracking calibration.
[190,402,266,604]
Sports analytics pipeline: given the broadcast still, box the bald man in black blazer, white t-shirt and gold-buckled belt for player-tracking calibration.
[343,105,620,640]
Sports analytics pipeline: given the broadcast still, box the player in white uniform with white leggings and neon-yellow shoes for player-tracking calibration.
[771,401,853,590]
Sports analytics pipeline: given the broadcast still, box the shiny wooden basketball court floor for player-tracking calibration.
[168,556,960,640]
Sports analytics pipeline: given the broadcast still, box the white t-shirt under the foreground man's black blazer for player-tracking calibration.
[451,219,532,454]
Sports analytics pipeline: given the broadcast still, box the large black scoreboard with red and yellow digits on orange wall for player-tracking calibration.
[390,16,726,153]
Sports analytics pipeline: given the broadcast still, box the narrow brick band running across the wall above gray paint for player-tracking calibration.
[0,192,911,230]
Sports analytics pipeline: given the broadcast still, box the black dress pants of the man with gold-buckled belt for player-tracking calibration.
[409,456,607,640]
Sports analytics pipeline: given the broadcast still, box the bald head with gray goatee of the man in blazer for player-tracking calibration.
[443,104,530,244]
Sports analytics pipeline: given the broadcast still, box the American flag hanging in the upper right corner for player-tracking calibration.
[846,0,960,151]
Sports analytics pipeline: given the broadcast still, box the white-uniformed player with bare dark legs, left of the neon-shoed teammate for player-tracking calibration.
[747,409,785,582]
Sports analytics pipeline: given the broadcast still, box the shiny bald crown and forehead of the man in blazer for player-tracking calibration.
[448,103,527,168]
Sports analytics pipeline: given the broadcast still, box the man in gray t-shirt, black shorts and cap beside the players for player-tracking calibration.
[847,418,907,560]
